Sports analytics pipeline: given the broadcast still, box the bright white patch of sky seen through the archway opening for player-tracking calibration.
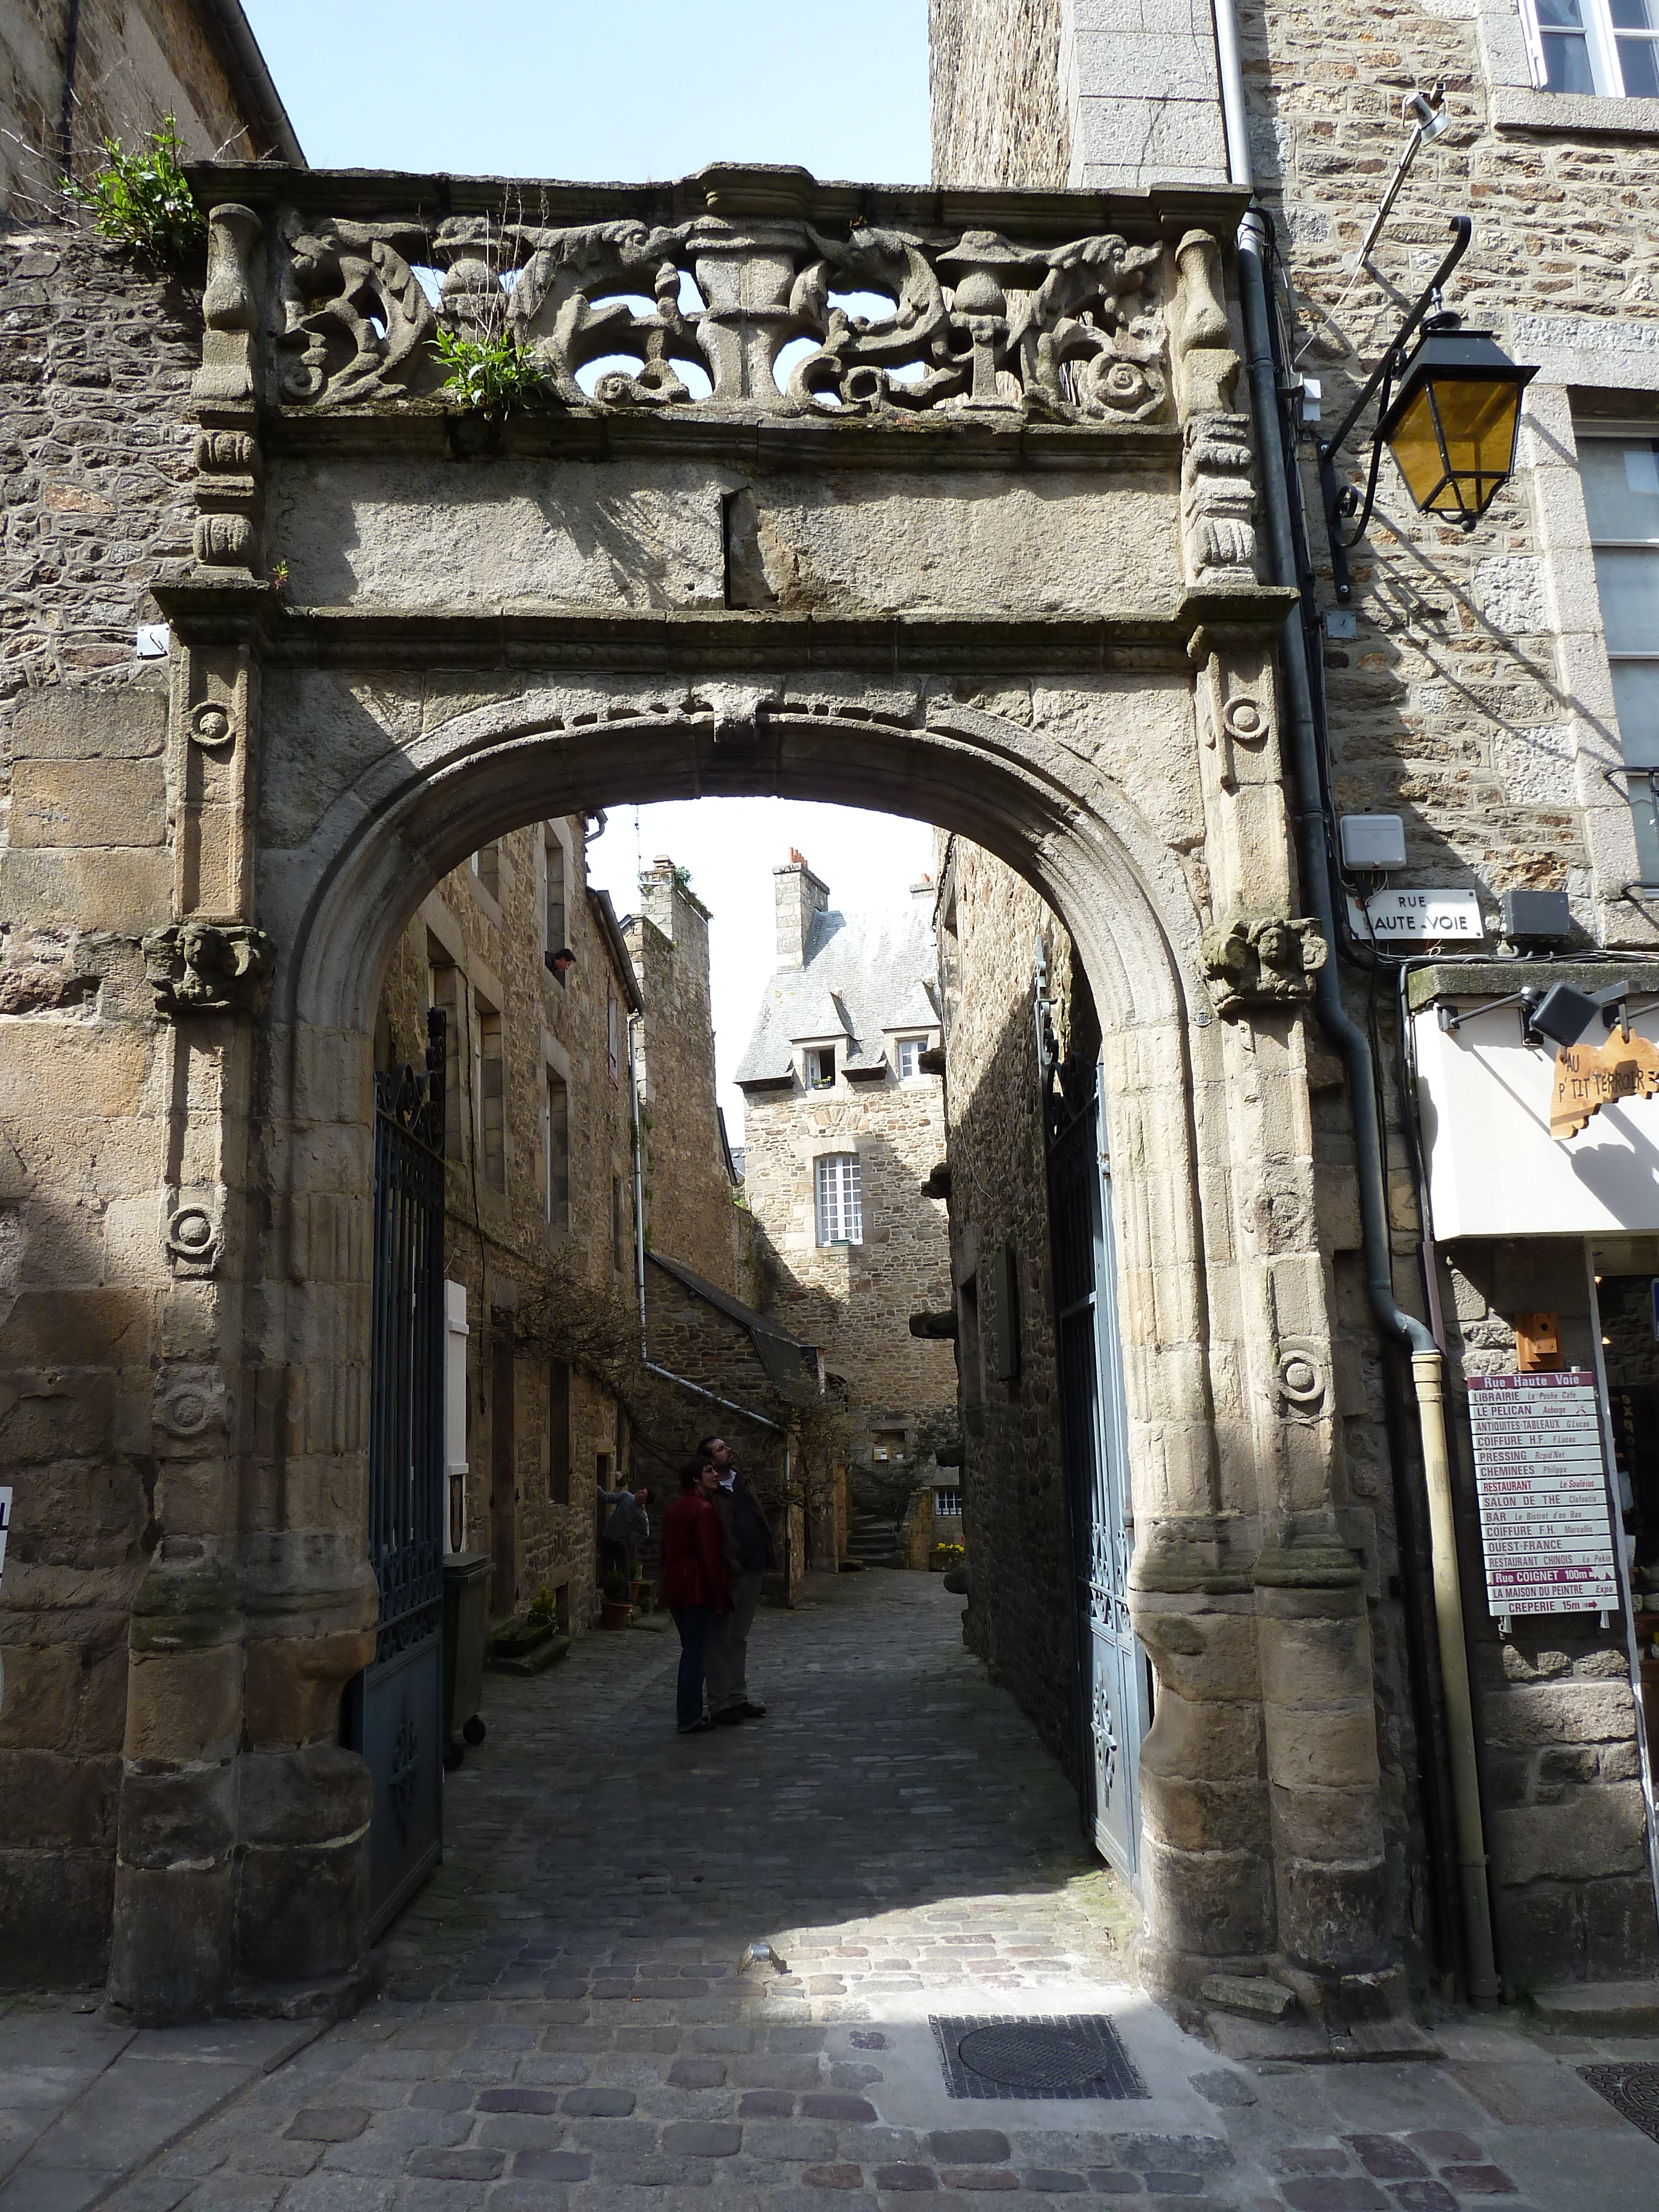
[588,799,933,1144]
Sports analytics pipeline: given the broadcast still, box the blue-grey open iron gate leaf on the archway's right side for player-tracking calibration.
[1048,1068,1146,1887]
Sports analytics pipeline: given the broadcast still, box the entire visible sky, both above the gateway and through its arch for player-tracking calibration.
[243,0,947,1144]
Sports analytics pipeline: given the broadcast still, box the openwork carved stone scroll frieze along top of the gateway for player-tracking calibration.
[253,208,1168,425]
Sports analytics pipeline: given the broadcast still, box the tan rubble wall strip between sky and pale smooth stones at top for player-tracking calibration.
[927,0,1066,186]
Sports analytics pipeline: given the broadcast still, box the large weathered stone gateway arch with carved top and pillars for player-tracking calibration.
[0,170,1389,2013]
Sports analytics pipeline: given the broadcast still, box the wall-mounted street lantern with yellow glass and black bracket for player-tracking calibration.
[1318,215,1537,599]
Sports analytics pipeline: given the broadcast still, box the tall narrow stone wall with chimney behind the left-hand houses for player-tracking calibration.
[624,858,748,1298]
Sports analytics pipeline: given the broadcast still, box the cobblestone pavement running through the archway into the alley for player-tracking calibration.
[19,1573,1659,2212]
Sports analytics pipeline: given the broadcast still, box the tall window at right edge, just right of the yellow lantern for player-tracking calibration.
[1575,422,1659,883]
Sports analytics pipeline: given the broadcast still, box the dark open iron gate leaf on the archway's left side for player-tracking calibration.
[347,1009,445,1938]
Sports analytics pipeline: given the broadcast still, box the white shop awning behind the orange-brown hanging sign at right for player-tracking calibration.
[1411,1009,1659,1243]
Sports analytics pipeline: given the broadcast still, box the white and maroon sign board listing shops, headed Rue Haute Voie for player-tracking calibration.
[1469,1367,1619,1619]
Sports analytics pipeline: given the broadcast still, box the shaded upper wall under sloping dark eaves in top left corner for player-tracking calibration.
[0,0,288,210]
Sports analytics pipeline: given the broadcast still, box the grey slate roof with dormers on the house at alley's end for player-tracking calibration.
[737,902,938,1084]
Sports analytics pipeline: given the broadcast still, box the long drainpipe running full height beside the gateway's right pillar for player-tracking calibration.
[1214,0,1498,2004]
